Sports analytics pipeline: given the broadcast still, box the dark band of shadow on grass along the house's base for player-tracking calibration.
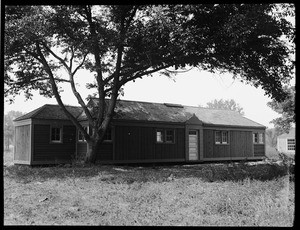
[4,162,294,184]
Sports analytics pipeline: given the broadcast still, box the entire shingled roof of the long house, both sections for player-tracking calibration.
[15,98,265,128]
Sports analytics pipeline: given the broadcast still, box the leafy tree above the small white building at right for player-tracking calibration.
[267,86,296,134]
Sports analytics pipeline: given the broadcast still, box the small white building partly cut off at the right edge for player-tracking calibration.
[277,128,296,154]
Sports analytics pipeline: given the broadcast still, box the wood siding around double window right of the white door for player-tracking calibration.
[203,129,253,159]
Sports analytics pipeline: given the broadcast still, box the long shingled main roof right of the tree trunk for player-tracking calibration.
[80,98,265,128]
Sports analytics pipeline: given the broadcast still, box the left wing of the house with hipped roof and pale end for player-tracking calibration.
[14,104,82,165]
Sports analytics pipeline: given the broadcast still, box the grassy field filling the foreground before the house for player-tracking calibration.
[4,148,295,226]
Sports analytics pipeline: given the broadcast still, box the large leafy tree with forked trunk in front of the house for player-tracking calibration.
[4,4,294,163]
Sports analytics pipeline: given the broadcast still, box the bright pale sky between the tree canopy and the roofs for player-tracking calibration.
[4,69,295,128]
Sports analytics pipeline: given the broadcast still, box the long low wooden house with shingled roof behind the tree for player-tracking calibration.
[14,98,266,165]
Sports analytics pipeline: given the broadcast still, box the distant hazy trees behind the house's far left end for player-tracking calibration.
[4,110,22,150]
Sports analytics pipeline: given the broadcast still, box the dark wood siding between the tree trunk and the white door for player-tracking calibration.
[115,126,185,161]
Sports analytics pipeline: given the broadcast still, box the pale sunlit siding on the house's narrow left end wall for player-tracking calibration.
[14,125,31,162]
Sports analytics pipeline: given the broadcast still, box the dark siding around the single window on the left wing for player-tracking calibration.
[33,125,76,163]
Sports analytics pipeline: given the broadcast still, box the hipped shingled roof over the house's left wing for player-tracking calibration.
[14,104,83,121]
